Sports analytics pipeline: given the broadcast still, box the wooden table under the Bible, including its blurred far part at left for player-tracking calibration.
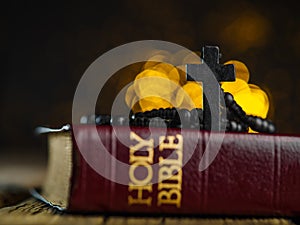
[0,150,300,225]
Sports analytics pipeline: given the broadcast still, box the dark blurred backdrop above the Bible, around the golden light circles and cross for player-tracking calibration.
[0,0,300,151]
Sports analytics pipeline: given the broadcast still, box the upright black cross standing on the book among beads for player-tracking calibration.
[186,46,235,131]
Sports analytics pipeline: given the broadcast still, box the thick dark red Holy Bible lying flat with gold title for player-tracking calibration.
[35,124,300,216]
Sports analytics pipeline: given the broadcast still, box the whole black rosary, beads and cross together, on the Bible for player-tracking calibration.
[88,46,276,133]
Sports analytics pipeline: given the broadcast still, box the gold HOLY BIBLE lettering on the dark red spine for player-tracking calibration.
[128,132,183,208]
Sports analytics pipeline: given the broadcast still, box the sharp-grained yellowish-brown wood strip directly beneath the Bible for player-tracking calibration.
[0,194,297,225]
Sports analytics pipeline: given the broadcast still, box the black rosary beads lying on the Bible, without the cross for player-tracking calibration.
[82,92,276,133]
